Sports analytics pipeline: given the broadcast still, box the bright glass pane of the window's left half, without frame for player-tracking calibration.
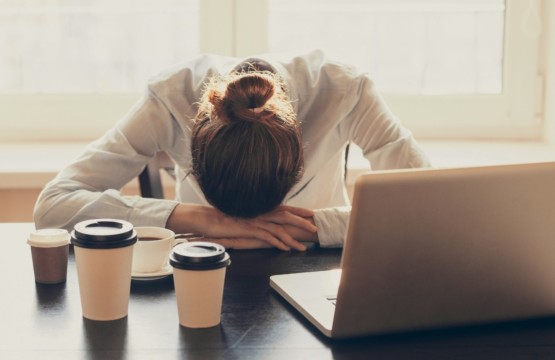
[0,0,199,94]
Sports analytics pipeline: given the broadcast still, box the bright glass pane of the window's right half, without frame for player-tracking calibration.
[268,0,505,95]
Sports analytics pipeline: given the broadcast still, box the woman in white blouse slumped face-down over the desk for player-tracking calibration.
[34,51,429,250]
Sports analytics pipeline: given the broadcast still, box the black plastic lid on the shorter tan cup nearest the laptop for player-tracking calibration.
[170,241,231,270]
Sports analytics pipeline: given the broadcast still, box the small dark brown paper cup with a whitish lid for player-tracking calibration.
[27,229,69,284]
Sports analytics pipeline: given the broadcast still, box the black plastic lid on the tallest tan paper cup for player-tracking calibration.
[71,219,137,249]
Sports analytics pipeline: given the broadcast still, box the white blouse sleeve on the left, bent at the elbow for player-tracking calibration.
[34,90,178,230]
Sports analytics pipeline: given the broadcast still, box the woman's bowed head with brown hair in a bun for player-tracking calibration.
[191,72,303,218]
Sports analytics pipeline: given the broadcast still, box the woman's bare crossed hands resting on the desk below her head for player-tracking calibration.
[166,204,317,251]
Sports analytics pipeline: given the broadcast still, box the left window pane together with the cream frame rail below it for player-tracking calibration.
[0,0,200,140]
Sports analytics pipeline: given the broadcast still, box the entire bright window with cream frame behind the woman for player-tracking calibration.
[0,0,547,140]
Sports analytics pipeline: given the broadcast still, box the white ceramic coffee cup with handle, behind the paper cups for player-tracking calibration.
[132,226,187,275]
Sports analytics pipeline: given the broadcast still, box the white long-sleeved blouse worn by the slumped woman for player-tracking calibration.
[34,51,429,247]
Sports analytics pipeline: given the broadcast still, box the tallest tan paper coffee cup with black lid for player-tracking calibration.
[71,219,137,321]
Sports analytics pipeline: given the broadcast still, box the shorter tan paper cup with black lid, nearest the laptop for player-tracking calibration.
[170,241,231,328]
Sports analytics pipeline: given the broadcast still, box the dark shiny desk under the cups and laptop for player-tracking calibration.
[0,224,555,360]
